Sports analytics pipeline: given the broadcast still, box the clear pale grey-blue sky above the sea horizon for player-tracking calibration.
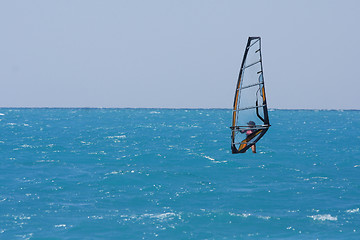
[0,0,360,109]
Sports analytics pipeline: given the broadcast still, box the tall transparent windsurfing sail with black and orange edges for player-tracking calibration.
[230,37,270,153]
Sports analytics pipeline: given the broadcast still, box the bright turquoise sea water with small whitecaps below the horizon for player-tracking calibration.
[0,108,360,239]
